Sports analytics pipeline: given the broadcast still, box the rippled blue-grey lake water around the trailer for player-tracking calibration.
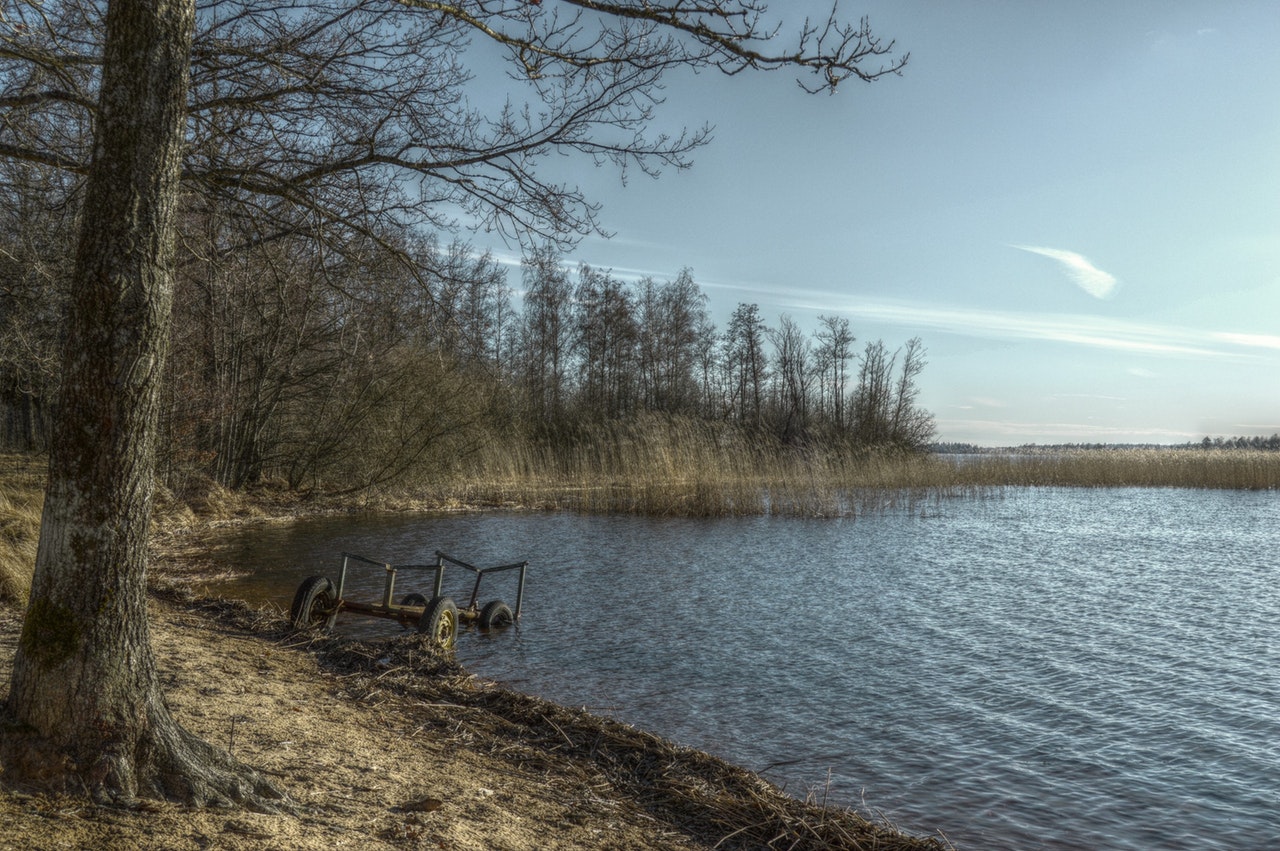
[207,489,1280,851]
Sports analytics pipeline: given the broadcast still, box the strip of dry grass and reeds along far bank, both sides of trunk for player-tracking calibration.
[0,437,1280,601]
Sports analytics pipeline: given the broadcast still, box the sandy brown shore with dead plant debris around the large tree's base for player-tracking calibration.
[0,545,943,851]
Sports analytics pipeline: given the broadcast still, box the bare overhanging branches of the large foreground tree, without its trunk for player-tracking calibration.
[0,0,906,252]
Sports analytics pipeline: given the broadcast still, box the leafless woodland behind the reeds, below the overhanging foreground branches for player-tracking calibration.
[0,216,934,493]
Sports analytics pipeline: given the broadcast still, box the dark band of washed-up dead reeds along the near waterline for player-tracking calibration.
[247,593,951,851]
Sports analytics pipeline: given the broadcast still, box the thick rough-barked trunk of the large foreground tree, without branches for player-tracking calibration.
[0,0,280,804]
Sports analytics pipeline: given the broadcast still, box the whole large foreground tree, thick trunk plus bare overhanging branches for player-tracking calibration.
[0,0,905,805]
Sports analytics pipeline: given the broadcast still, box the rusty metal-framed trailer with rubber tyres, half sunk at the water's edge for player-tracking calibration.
[289,550,529,649]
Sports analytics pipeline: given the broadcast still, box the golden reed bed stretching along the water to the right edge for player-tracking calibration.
[445,420,1280,517]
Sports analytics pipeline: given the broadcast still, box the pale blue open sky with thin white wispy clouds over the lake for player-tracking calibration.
[496,0,1280,447]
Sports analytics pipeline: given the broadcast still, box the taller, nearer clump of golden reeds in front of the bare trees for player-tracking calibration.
[453,417,983,517]
